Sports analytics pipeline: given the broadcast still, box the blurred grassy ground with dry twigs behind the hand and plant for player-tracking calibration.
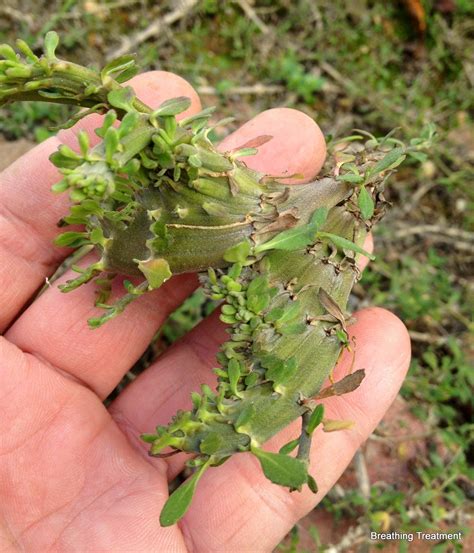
[0,0,474,552]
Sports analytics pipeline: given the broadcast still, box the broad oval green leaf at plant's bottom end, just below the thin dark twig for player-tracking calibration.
[252,447,308,489]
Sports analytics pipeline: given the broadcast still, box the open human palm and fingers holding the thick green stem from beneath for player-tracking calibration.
[0,72,410,553]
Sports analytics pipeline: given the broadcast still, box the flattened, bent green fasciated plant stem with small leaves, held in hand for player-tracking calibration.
[0,32,433,526]
